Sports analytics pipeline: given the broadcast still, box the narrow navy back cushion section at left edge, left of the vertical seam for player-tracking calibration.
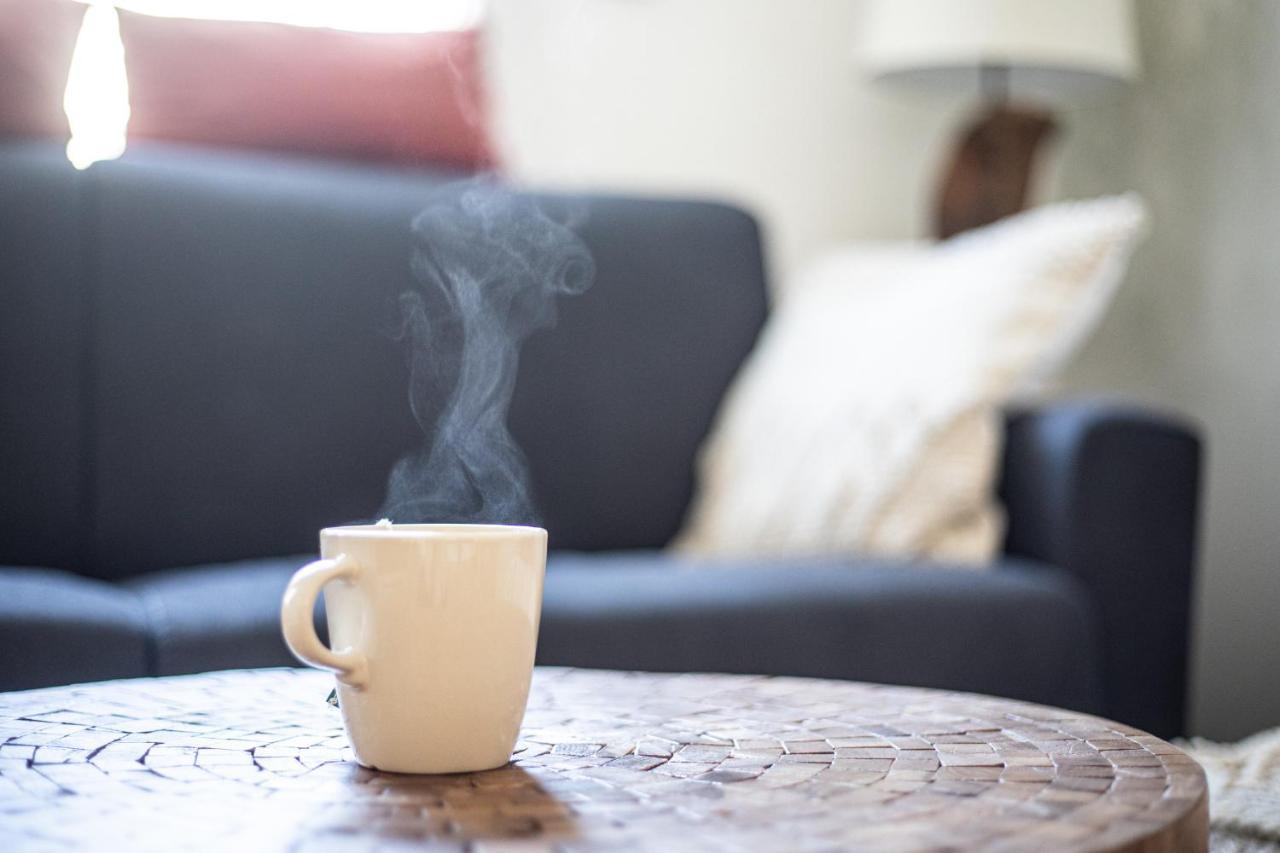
[0,141,91,569]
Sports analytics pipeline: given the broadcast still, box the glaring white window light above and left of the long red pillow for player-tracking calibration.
[63,0,484,169]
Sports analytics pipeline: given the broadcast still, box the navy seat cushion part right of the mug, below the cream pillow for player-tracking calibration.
[538,552,1102,712]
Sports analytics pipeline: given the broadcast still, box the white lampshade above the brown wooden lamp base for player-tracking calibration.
[859,0,1138,101]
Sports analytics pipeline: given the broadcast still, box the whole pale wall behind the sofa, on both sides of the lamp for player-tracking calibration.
[490,0,1280,738]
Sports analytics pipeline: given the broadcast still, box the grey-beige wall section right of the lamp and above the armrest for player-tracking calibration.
[1060,0,1280,738]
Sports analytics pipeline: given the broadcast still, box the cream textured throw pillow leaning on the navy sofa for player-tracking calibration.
[675,195,1146,564]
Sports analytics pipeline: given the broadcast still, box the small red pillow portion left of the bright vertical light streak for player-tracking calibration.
[0,0,84,140]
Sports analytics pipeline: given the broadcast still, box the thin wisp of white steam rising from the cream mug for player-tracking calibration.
[381,179,595,524]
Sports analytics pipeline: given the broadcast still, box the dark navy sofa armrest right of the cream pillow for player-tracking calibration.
[1000,402,1201,736]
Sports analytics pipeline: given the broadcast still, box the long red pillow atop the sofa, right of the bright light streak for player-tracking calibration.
[119,10,492,169]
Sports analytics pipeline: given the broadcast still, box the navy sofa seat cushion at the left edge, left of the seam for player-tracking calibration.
[0,566,147,690]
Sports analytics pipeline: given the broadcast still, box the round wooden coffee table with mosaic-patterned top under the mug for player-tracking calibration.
[0,669,1207,852]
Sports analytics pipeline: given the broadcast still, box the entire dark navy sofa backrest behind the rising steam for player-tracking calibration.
[0,140,765,576]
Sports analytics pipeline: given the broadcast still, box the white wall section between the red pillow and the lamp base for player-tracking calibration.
[489,0,950,285]
